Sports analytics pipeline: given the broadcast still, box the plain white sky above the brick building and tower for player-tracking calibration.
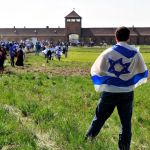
[0,0,150,28]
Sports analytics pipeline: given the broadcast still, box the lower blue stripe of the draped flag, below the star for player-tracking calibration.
[92,70,148,87]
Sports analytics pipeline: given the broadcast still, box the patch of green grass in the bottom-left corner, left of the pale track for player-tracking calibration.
[0,108,36,150]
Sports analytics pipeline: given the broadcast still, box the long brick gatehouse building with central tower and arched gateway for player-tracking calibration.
[0,10,150,45]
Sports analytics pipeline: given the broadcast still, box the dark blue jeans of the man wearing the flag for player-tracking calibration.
[86,91,134,150]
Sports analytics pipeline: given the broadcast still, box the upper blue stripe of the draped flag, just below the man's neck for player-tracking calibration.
[112,45,137,58]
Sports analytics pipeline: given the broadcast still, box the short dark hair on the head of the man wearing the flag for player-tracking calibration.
[115,27,130,41]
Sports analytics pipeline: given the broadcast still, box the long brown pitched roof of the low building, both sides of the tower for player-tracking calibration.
[0,27,150,37]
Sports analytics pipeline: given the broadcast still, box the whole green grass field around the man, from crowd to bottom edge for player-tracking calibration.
[0,46,150,150]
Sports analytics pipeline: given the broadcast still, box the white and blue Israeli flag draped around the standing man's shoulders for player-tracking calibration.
[91,42,148,93]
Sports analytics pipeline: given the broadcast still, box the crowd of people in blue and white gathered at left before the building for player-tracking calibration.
[0,41,68,73]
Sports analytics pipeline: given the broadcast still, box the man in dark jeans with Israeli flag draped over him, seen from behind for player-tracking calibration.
[85,27,148,150]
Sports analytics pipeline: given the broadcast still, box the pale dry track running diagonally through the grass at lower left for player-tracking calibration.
[2,105,60,150]
